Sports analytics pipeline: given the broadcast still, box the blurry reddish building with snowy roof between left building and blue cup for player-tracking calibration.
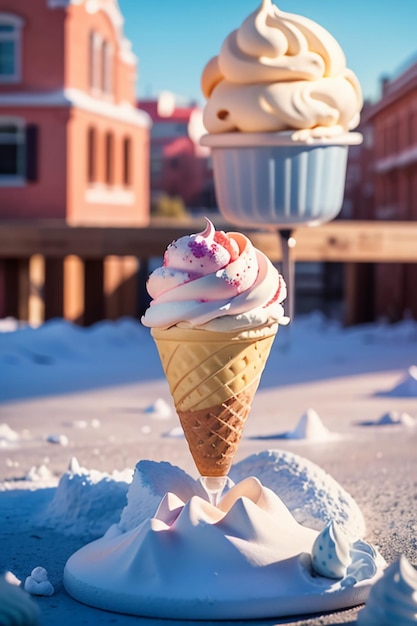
[138,92,216,209]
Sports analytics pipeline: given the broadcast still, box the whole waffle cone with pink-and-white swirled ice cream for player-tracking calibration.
[142,220,288,500]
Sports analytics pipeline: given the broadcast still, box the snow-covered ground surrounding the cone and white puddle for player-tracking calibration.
[0,313,417,626]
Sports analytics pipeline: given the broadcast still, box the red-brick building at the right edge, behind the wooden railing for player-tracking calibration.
[354,59,417,321]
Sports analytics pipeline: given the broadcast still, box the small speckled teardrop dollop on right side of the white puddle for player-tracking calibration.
[311,521,352,578]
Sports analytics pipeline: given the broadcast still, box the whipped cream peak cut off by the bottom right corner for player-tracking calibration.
[358,556,417,626]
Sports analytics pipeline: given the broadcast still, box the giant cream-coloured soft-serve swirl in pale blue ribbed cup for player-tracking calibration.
[201,0,363,228]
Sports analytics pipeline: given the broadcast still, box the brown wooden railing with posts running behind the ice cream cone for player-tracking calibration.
[0,218,417,325]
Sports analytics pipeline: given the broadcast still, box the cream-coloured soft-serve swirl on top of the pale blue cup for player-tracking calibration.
[201,0,363,140]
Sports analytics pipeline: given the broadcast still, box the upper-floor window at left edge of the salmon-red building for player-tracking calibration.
[0,13,23,83]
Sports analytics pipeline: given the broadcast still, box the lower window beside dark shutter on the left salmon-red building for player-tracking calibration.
[0,119,26,184]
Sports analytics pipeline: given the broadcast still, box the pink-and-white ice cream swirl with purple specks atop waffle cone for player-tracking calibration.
[142,218,288,331]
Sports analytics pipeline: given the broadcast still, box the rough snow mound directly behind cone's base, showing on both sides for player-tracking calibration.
[119,450,365,541]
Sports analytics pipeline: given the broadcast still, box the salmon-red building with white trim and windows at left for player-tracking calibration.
[0,0,150,225]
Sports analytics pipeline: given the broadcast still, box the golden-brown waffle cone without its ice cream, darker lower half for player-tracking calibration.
[152,323,278,476]
